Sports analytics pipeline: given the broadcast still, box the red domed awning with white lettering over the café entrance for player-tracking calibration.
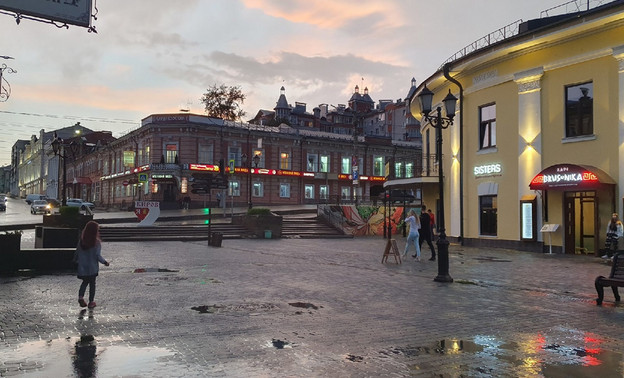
[529,164,615,190]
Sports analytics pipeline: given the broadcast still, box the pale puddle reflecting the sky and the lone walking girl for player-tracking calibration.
[0,335,199,377]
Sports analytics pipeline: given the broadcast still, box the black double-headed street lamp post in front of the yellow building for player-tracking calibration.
[418,85,457,282]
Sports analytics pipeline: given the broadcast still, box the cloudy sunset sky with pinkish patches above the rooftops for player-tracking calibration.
[0,0,572,166]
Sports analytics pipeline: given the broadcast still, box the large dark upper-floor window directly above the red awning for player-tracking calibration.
[565,82,594,138]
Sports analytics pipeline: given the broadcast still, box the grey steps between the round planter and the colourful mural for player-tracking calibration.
[282,212,353,239]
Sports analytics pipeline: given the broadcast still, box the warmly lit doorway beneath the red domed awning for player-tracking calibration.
[564,192,598,254]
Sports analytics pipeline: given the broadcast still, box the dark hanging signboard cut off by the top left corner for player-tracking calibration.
[0,0,92,28]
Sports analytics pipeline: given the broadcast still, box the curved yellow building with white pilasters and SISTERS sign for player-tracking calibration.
[410,1,624,254]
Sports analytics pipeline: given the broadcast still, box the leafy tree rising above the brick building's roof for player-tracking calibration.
[201,84,247,121]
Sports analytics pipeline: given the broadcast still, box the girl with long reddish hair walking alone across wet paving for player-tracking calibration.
[74,221,110,308]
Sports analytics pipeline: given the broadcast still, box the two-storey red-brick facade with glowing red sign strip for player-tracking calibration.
[92,114,421,208]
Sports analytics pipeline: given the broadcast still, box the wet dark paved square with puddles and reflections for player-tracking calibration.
[0,237,624,377]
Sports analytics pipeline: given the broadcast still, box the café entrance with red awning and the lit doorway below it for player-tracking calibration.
[529,164,616,255]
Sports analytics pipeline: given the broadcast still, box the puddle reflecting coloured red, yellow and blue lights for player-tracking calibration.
[386,327,624,377]
